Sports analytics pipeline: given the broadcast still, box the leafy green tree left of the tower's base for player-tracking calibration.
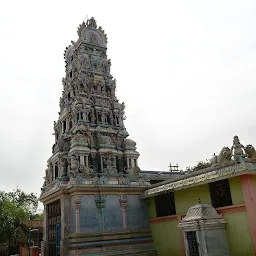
[0,188,38,244]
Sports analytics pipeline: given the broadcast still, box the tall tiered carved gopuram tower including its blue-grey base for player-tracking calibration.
[40,18,156,256]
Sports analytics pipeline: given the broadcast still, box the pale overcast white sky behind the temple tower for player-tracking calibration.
[0,0,256,203]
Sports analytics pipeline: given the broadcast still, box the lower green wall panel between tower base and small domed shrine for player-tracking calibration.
[151,220,181,256]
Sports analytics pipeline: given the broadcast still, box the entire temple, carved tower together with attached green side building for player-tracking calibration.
[40,18,256,256]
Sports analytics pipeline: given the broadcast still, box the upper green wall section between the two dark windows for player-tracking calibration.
[174,184,211,214]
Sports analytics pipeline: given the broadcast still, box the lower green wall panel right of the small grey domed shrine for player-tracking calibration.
[224,212,254,256]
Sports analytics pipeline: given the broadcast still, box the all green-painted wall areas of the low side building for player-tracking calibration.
[150,176,253,256]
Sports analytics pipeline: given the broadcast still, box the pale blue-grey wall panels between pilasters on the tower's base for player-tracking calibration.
[71,195,149,233]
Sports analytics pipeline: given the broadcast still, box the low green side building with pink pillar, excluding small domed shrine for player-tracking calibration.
[142,138,256,256]
